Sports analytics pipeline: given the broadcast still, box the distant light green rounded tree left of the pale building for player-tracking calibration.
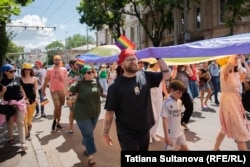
[65,34,95,49]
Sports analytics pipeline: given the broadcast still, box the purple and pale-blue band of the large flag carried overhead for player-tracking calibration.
[78,33,250,63]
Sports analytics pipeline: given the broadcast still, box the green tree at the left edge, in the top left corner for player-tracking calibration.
[0,0,33,66]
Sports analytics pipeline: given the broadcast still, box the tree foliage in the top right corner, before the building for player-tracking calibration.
[221,0,250,35]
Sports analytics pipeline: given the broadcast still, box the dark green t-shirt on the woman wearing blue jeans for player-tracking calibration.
[70,79,101,120]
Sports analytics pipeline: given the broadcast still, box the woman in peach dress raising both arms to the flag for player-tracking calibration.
[214,55,250,151]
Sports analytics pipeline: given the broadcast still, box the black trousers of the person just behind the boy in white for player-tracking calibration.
[181,89,194,124]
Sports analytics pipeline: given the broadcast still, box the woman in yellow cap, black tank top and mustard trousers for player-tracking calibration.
[21,63,38,138]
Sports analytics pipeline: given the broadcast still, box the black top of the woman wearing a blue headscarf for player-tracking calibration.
[0,76,23,101]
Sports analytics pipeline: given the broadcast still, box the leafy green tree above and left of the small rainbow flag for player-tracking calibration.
[76,0,127,38]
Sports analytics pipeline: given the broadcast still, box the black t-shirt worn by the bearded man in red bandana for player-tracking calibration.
[105,71,162,133]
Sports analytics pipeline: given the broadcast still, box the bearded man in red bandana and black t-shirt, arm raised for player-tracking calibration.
[103,49,170,151]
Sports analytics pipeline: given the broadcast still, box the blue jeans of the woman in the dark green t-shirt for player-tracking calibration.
[76,117,98,155]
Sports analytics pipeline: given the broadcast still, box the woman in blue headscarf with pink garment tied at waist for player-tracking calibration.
[0,64,28,150]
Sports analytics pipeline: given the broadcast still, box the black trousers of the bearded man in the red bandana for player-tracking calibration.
[117,131,149,151]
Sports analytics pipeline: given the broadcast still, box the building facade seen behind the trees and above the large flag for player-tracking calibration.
[96,0,250,49]
